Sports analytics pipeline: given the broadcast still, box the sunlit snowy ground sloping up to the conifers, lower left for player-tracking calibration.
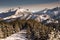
[0,30,28,40]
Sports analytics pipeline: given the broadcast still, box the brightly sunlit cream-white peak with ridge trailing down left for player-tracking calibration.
[3,9,31,20]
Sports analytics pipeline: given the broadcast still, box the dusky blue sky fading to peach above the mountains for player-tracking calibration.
[0,0,60,11]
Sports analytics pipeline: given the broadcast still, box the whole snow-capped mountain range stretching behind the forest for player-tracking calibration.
[0,7,60,23]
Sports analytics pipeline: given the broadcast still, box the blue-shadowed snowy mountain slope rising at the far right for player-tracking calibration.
[34,7,60,19]
